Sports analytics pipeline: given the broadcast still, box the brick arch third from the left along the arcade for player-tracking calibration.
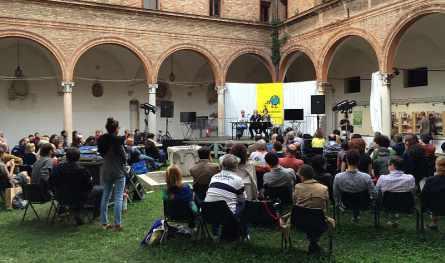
[153,44,223,85]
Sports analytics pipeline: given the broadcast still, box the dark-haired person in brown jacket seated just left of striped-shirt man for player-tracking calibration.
[190,146,220,201]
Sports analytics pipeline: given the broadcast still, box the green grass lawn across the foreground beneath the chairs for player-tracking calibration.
[0,192,445,263]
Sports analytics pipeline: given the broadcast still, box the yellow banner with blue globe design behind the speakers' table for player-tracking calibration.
[256,83,284,125]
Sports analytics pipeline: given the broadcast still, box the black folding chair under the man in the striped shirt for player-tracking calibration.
[201,201,241,241]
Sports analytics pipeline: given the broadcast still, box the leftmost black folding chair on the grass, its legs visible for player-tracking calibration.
[22,184,56,223]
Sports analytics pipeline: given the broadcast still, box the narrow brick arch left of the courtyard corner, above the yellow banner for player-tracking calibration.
[223,48,277,82]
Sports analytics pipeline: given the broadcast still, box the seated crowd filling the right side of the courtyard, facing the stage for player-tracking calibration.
[163,131,445,252]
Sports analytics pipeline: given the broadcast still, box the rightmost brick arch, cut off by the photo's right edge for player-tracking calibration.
[383,4,445,73]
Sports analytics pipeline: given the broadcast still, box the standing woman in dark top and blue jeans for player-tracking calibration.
[98,118,127,230]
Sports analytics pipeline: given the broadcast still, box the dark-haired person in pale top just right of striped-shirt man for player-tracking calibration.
[230,143,258,201]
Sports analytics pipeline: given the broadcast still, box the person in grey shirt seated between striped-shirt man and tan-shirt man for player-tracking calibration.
[264,153,297,191]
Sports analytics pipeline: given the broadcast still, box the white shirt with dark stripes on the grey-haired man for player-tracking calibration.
[204,170,245,214]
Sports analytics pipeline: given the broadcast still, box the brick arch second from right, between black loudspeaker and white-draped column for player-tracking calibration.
[317,28,383,82]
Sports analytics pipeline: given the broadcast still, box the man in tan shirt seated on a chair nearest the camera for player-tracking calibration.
[294,164,335,254]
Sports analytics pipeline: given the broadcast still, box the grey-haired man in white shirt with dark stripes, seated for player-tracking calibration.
[204,154,248,241]
